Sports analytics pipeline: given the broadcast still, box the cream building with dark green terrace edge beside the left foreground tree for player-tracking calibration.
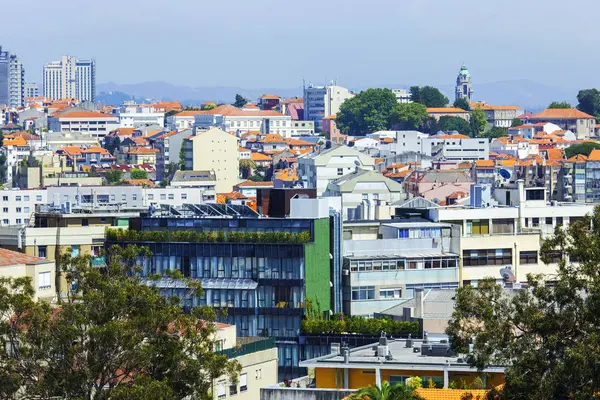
[213,322,278,400]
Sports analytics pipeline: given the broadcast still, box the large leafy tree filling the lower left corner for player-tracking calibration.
[0,246,240,400]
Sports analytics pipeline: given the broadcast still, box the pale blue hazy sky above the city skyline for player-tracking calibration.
[0,0,600,88]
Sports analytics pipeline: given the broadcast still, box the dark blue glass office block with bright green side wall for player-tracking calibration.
[107,204,339,379]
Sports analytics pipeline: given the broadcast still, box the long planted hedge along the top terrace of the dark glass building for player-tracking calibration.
[106,229,310,243]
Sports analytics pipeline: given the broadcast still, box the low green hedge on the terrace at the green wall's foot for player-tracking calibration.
[300,314,419,335]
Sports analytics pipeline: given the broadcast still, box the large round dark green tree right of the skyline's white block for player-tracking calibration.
[336,89,398,136]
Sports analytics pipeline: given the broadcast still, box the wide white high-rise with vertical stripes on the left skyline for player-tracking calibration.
[44,56,96,102]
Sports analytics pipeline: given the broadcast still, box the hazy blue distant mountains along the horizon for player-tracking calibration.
[97,79,577,111]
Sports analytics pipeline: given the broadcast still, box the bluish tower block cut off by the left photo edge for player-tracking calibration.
[0,46,25,108]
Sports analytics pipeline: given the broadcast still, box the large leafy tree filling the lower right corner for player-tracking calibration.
[446,206,600,399]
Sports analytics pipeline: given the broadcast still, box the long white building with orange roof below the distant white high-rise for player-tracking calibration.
[48,109,119,139]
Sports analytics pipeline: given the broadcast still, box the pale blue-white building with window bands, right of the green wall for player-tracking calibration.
[342,217,460,316]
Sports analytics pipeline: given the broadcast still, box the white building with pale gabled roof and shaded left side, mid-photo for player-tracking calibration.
[298,146,375,196]
